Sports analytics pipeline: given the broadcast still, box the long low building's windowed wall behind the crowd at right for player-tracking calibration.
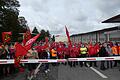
[71,27,120,43]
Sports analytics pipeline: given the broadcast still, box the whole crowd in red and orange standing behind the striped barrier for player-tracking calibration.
[0,42,120,77]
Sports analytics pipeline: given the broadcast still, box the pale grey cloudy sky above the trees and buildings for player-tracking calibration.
[19,0,120,35]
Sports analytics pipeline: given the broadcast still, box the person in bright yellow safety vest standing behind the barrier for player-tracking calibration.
[80,44,88,67]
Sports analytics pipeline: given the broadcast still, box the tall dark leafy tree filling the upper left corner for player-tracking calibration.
[0,0,26,41]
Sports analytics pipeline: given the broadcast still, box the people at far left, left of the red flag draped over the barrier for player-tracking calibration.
[0,44,15,77]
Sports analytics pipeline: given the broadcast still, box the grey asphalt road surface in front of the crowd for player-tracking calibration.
[3,64,120,80]
